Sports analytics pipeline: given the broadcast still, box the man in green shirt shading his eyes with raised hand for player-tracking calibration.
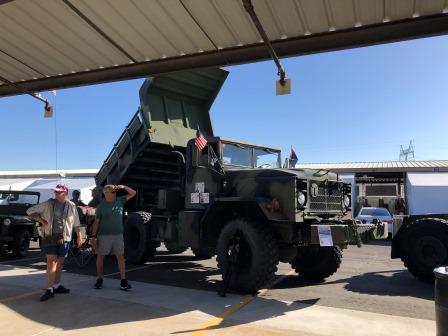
[92,185,136,290]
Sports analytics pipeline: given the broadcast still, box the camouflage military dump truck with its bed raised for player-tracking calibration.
[96,69,387,291]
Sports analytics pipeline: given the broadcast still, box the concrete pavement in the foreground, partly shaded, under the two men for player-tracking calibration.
[0,264,435,336]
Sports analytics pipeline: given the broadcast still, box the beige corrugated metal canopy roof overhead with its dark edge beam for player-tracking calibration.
[0,0,448,96]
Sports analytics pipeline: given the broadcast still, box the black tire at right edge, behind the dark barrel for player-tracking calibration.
[400,218,448,282]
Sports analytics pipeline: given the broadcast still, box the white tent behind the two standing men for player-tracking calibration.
[25,177,95,204]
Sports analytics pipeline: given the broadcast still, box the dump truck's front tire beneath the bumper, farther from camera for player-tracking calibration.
[291,246,342,281]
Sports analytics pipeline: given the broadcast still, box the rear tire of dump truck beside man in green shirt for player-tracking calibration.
[124,211,159,264]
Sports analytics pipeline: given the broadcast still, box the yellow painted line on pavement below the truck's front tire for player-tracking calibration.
[191,270,295,336]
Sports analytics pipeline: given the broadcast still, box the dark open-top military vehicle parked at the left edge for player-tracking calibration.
[0,190,40,258]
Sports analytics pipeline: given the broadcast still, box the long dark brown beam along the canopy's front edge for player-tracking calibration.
[0,14,448,97]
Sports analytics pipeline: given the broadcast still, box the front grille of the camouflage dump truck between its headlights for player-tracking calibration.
[309,181,343,213]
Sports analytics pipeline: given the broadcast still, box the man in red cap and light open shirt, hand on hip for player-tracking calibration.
[27,183,82,301]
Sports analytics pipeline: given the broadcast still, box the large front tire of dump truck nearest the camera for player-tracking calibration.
[217,219,279,292]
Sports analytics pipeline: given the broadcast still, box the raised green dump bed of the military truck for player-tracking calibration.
[96,69,227,211]
